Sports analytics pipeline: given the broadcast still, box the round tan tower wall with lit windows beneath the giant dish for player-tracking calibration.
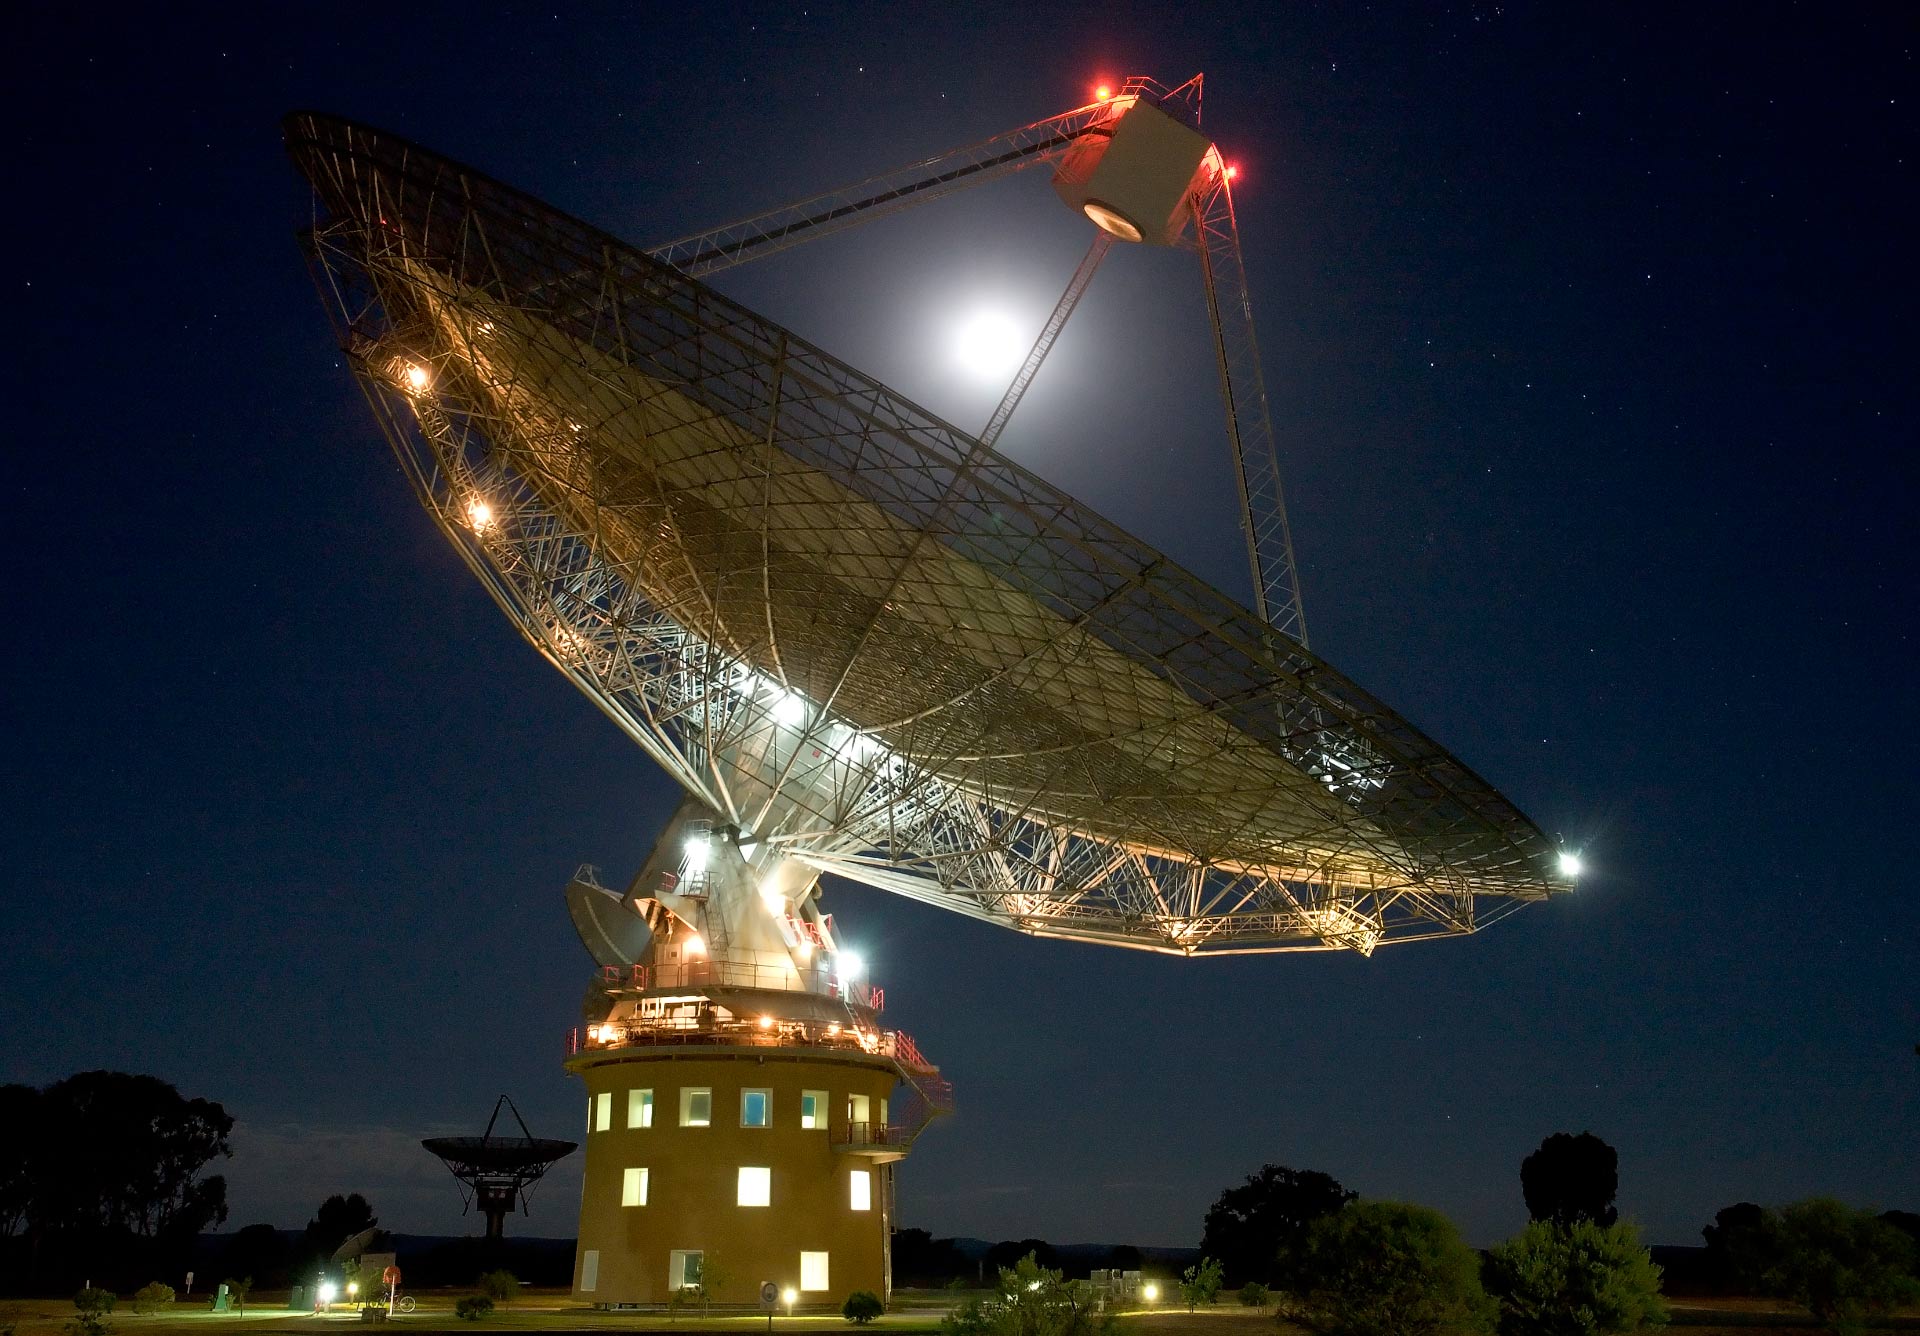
[568,1048,897,1309]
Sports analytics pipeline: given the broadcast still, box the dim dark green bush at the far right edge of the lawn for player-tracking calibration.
[1766,1198,1920,1334]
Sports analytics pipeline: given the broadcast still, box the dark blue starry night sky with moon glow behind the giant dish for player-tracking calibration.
[0,4,1920,1244]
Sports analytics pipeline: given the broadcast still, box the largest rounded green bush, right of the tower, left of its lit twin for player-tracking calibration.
[1281,1202,1494,1336]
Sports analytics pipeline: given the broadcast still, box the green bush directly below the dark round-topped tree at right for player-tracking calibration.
[1482,1221,1667,1336]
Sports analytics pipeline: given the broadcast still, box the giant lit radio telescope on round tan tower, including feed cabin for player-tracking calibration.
[286,77,1576,1303]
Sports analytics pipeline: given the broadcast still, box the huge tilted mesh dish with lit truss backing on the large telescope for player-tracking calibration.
[288,115,1569,954]
